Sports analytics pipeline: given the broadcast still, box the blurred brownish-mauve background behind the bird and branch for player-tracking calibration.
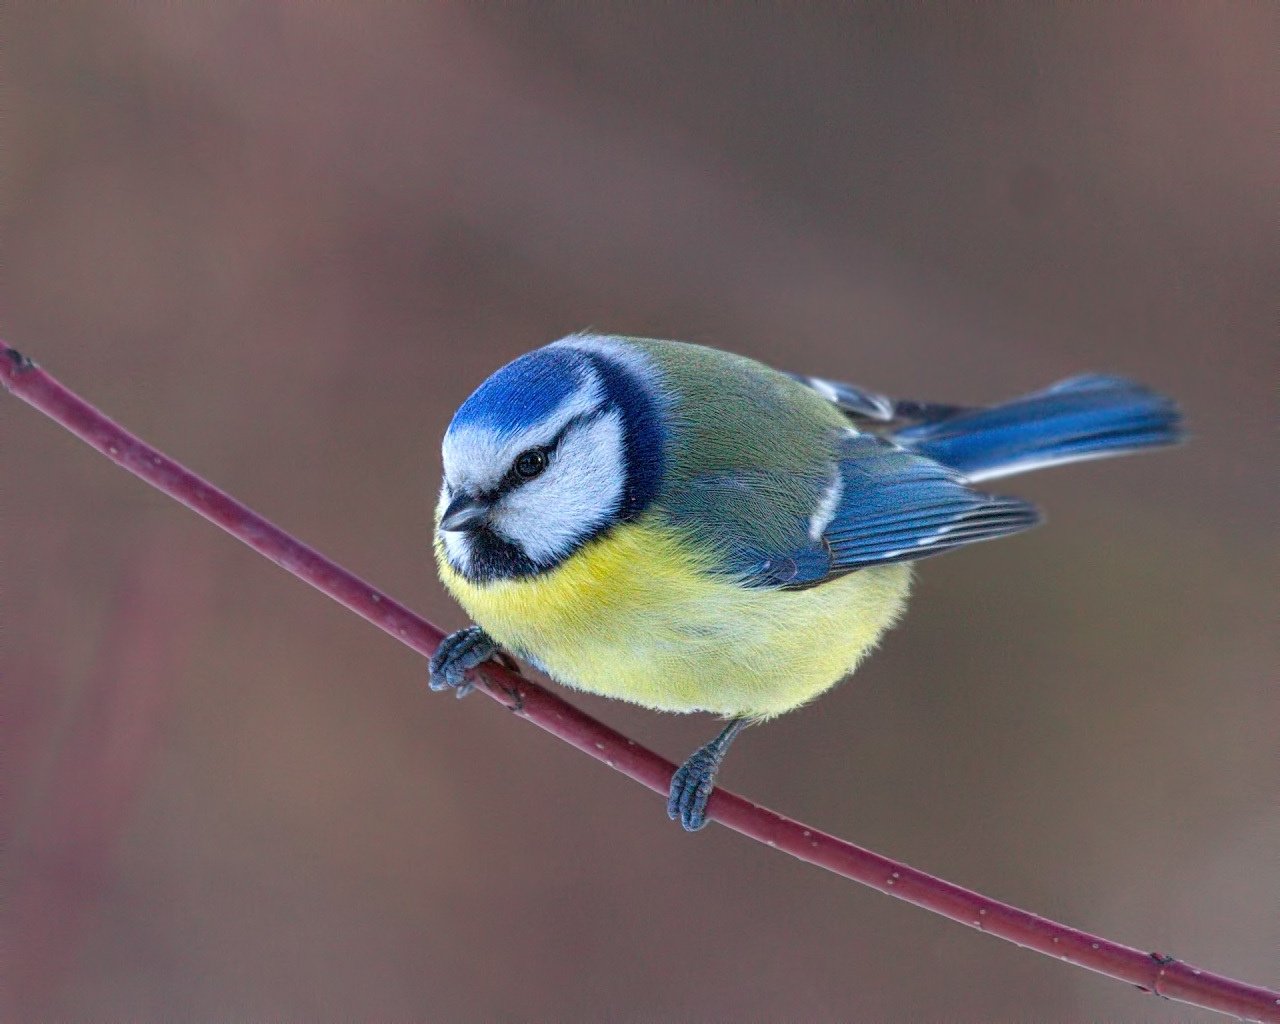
[0,3,1280,1021]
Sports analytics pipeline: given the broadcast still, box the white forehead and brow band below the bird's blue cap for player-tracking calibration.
[442,367,604,494]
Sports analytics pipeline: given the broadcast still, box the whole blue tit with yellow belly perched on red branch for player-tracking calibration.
[431,334,1180,831]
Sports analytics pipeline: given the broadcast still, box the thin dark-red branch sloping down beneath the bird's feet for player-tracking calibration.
[0,342,1280,1024]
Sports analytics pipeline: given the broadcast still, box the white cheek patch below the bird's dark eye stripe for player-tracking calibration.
[492,412,626,563]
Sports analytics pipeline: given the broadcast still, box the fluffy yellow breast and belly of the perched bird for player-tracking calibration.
[436,521,910,718]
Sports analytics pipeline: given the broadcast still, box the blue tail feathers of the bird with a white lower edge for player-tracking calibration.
[893,375,1183,481]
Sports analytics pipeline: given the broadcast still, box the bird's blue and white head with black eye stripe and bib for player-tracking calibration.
[436,335,663,582]
